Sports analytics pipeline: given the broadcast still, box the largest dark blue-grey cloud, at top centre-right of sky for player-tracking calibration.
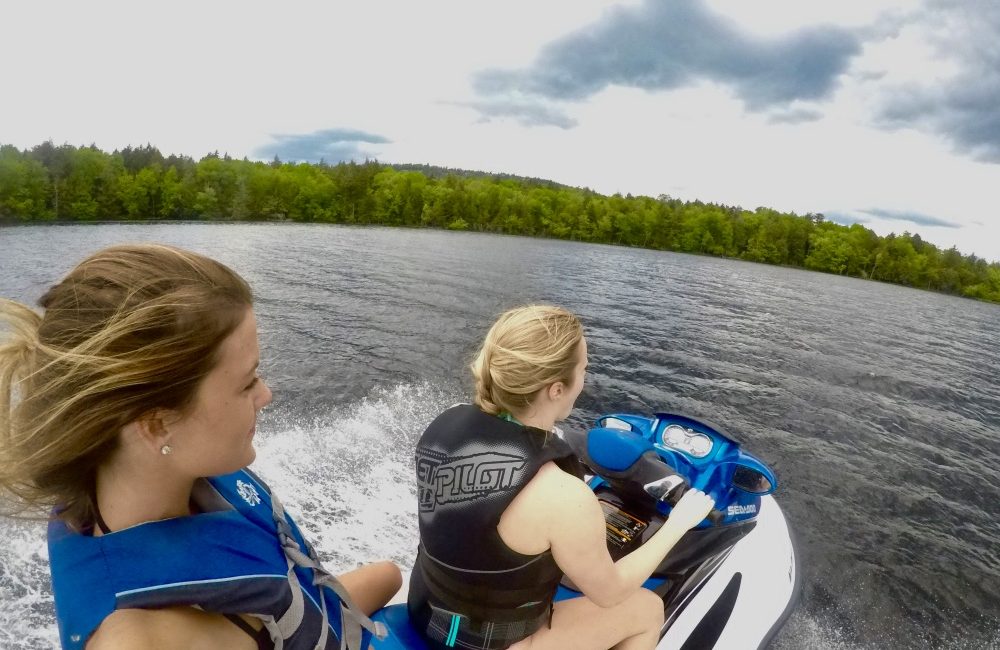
[473,0,861,111]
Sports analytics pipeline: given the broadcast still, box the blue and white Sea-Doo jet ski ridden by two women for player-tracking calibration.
[372,413,801,650]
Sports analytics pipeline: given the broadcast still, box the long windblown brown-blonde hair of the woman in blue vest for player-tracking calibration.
[0,244,253,527]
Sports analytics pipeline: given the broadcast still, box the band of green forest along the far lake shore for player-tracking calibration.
[0,142,1000,303]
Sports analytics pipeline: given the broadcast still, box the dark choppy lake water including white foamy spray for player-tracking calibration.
[0,224,1000,650]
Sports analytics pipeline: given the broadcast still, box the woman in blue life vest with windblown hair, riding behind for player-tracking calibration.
[0,245,401,650]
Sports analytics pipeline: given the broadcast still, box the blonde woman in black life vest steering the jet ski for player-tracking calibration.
[408,305,713,650]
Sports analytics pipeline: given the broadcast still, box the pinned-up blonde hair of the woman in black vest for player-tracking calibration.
[472,305,583,415]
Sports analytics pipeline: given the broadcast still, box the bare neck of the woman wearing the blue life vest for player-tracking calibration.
[96,462,194,531]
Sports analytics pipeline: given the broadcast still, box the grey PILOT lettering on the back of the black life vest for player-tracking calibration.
[417,449,524,512]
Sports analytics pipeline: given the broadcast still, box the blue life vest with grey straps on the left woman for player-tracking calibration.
[48,470,384,650]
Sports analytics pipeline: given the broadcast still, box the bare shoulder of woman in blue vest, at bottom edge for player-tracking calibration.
[86,607,256,650]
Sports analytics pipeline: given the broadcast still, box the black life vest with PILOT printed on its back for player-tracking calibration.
[408,404,582,650]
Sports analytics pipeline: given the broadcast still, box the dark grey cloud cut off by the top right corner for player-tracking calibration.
[878,0,1000,163]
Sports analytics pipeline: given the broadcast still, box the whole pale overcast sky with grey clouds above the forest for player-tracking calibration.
[0,0,1000,261]
